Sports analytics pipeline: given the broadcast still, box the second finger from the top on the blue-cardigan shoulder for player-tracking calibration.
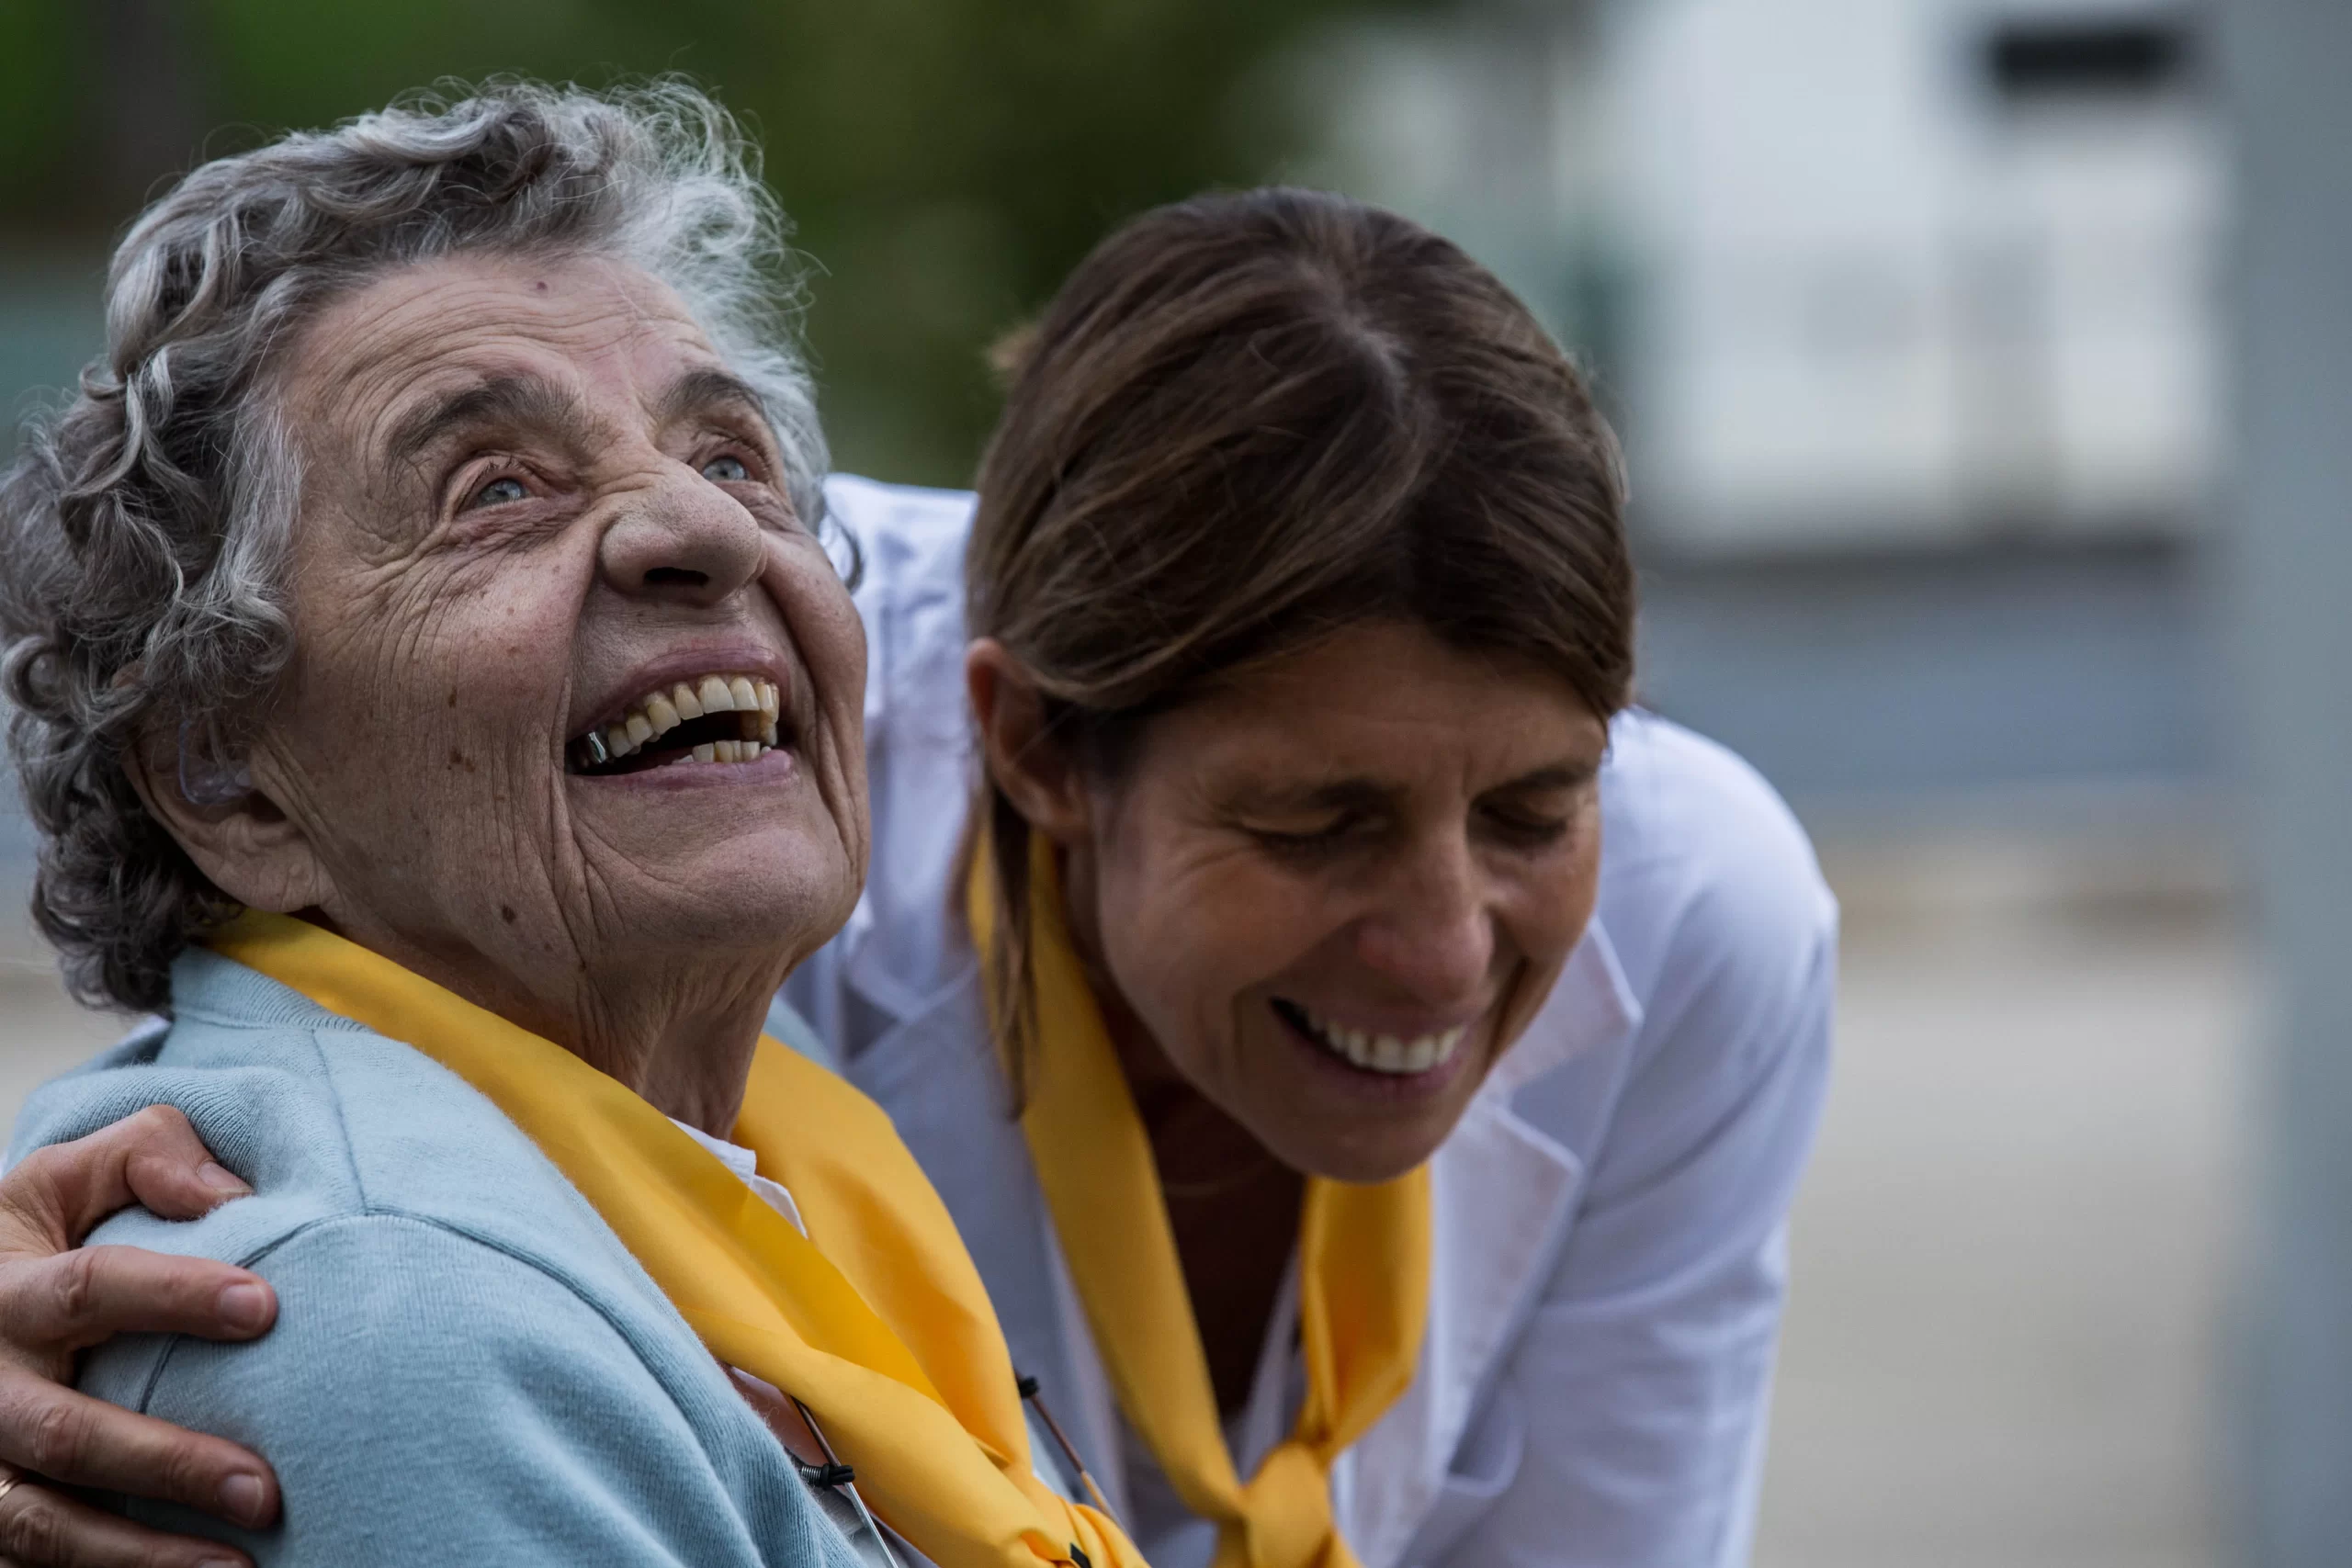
[0,1246,277,1349]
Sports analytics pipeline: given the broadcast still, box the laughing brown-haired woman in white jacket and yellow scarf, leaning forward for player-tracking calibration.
[0,156,1835,1568]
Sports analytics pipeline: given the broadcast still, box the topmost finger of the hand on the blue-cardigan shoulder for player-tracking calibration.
[0,1105,252,1251]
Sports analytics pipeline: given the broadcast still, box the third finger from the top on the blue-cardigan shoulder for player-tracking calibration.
[0,1373,277,1523]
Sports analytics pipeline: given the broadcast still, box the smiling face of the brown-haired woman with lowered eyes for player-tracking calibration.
[1070,623,1609,1180]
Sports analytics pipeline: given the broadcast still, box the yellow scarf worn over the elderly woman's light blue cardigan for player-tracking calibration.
[211,912,1143,1568]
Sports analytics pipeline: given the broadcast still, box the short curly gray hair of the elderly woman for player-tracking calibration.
[0,80,826,1009]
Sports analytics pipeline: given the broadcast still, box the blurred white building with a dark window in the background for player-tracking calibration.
[1322,0,2221,552]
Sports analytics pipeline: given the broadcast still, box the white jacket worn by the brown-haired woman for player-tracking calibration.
[786,478,1837,1568]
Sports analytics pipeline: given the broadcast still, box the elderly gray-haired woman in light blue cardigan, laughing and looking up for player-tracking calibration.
[0,87,1129,1568]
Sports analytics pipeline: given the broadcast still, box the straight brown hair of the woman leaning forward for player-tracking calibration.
[957,188,1634,1098]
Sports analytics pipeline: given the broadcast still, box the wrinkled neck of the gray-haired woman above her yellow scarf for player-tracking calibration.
[303,909,790,1138]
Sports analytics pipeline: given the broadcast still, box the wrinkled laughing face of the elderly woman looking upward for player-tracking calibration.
[231,259,868,1030]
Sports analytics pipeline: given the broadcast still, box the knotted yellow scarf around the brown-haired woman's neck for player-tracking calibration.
[967,835,1430,1568]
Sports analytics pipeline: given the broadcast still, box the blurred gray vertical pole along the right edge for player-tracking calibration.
[2209,0,2352,1568]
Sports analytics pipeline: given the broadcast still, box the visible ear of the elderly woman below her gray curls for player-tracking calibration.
[122,727,334,915]
